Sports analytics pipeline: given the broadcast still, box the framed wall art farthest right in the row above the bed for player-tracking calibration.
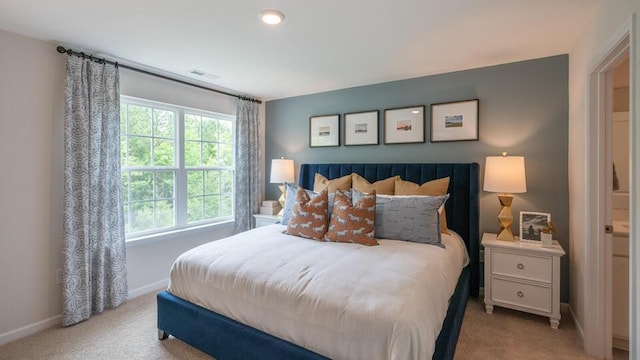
[431,99,480,142]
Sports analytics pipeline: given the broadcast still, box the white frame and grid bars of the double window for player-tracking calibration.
[121,97,235,240]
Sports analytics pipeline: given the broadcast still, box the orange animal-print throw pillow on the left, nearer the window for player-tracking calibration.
[287,189,329,240]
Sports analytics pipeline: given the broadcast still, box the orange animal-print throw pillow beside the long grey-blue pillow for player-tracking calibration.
[324,190,378,246]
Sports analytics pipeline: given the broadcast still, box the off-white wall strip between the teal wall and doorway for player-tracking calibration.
[569,0,640,351]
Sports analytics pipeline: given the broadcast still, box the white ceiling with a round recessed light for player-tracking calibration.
[0,0,601,100]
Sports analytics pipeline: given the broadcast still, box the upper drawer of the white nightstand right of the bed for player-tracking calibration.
[491,250,553,284]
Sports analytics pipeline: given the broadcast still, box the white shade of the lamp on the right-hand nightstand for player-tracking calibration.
[484,156,527,194]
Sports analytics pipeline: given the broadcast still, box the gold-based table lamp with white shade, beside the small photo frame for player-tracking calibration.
[484,152,527,241]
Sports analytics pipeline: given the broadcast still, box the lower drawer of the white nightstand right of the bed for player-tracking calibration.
[491,278,551,313]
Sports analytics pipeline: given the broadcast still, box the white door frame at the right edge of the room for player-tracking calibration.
[578,14,640,359]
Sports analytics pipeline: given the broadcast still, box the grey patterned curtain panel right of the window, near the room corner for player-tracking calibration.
[234,99,262,233]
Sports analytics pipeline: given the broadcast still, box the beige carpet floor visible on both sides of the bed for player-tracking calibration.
[0,293,604,360]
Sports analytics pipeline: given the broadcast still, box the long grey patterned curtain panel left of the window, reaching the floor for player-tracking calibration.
[62,56,128,326]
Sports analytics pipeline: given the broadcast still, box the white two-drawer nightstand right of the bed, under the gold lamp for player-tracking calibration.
[482,233,565,329]
